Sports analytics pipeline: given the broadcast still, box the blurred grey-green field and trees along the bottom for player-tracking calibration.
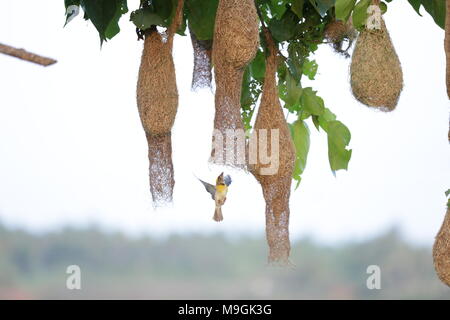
[0,227,450,299]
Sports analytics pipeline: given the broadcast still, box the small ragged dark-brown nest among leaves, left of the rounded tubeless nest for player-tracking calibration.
[324,18,358,58]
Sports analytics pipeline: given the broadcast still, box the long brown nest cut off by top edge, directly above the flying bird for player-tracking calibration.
[211,0,259,167]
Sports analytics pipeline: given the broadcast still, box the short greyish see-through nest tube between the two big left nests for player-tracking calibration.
[189,30,212,91]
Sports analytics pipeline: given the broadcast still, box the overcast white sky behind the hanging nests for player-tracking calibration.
[0,0,450,244]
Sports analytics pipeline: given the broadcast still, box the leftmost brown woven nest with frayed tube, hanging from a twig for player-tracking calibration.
[137,0,184,205]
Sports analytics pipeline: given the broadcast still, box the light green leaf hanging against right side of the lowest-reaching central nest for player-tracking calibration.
[289,120,310,189]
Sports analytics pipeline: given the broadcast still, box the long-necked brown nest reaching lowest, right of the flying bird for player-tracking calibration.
[248,29,296,264]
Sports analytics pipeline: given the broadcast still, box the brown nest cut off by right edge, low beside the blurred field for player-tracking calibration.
[433,208,450,286]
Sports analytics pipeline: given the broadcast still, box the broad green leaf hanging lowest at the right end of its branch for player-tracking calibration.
[327,120,352,173]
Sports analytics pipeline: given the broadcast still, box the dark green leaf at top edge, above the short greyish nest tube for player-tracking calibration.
[184,0,219,40]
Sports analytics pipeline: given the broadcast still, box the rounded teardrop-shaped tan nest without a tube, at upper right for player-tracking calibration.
[350,20,403,112]
